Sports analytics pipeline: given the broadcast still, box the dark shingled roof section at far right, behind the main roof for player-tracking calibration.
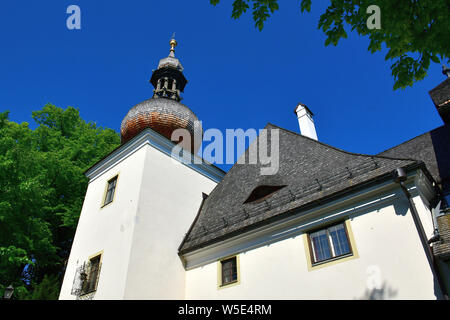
[379,124,450,188]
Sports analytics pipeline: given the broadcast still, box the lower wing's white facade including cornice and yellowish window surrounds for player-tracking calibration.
[186,176,441,300]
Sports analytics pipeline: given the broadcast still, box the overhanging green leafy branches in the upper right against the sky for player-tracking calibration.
[210,0,450,89]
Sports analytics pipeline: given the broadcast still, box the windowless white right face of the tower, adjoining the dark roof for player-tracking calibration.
[125,147,216,299]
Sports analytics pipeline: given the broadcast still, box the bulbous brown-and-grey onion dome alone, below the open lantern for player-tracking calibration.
[120,98,203,154]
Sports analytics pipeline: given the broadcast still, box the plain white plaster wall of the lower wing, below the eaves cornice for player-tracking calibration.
[186,197,442,300]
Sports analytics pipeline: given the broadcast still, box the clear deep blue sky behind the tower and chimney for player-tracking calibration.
[0,0,444,169]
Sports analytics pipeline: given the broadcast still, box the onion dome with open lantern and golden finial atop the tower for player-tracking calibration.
[120,39,203,154]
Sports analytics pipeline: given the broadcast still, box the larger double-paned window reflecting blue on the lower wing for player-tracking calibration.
[309,223,352,263]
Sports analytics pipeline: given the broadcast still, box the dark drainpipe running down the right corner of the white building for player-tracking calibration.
[393,168,449,300]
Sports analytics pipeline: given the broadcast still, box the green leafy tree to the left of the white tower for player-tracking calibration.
[0,104,119,299]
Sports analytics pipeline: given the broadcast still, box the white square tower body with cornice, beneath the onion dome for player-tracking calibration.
[60,130,223,299]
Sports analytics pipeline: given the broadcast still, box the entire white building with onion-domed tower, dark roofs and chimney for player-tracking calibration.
[60,40,450,300]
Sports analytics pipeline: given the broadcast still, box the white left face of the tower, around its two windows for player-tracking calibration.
[60,149,146,299]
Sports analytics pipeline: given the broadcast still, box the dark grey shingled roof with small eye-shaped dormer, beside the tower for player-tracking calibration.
[179,124,419,254]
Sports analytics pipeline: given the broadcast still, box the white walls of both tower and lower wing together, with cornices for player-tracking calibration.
[60,130,441,300]
